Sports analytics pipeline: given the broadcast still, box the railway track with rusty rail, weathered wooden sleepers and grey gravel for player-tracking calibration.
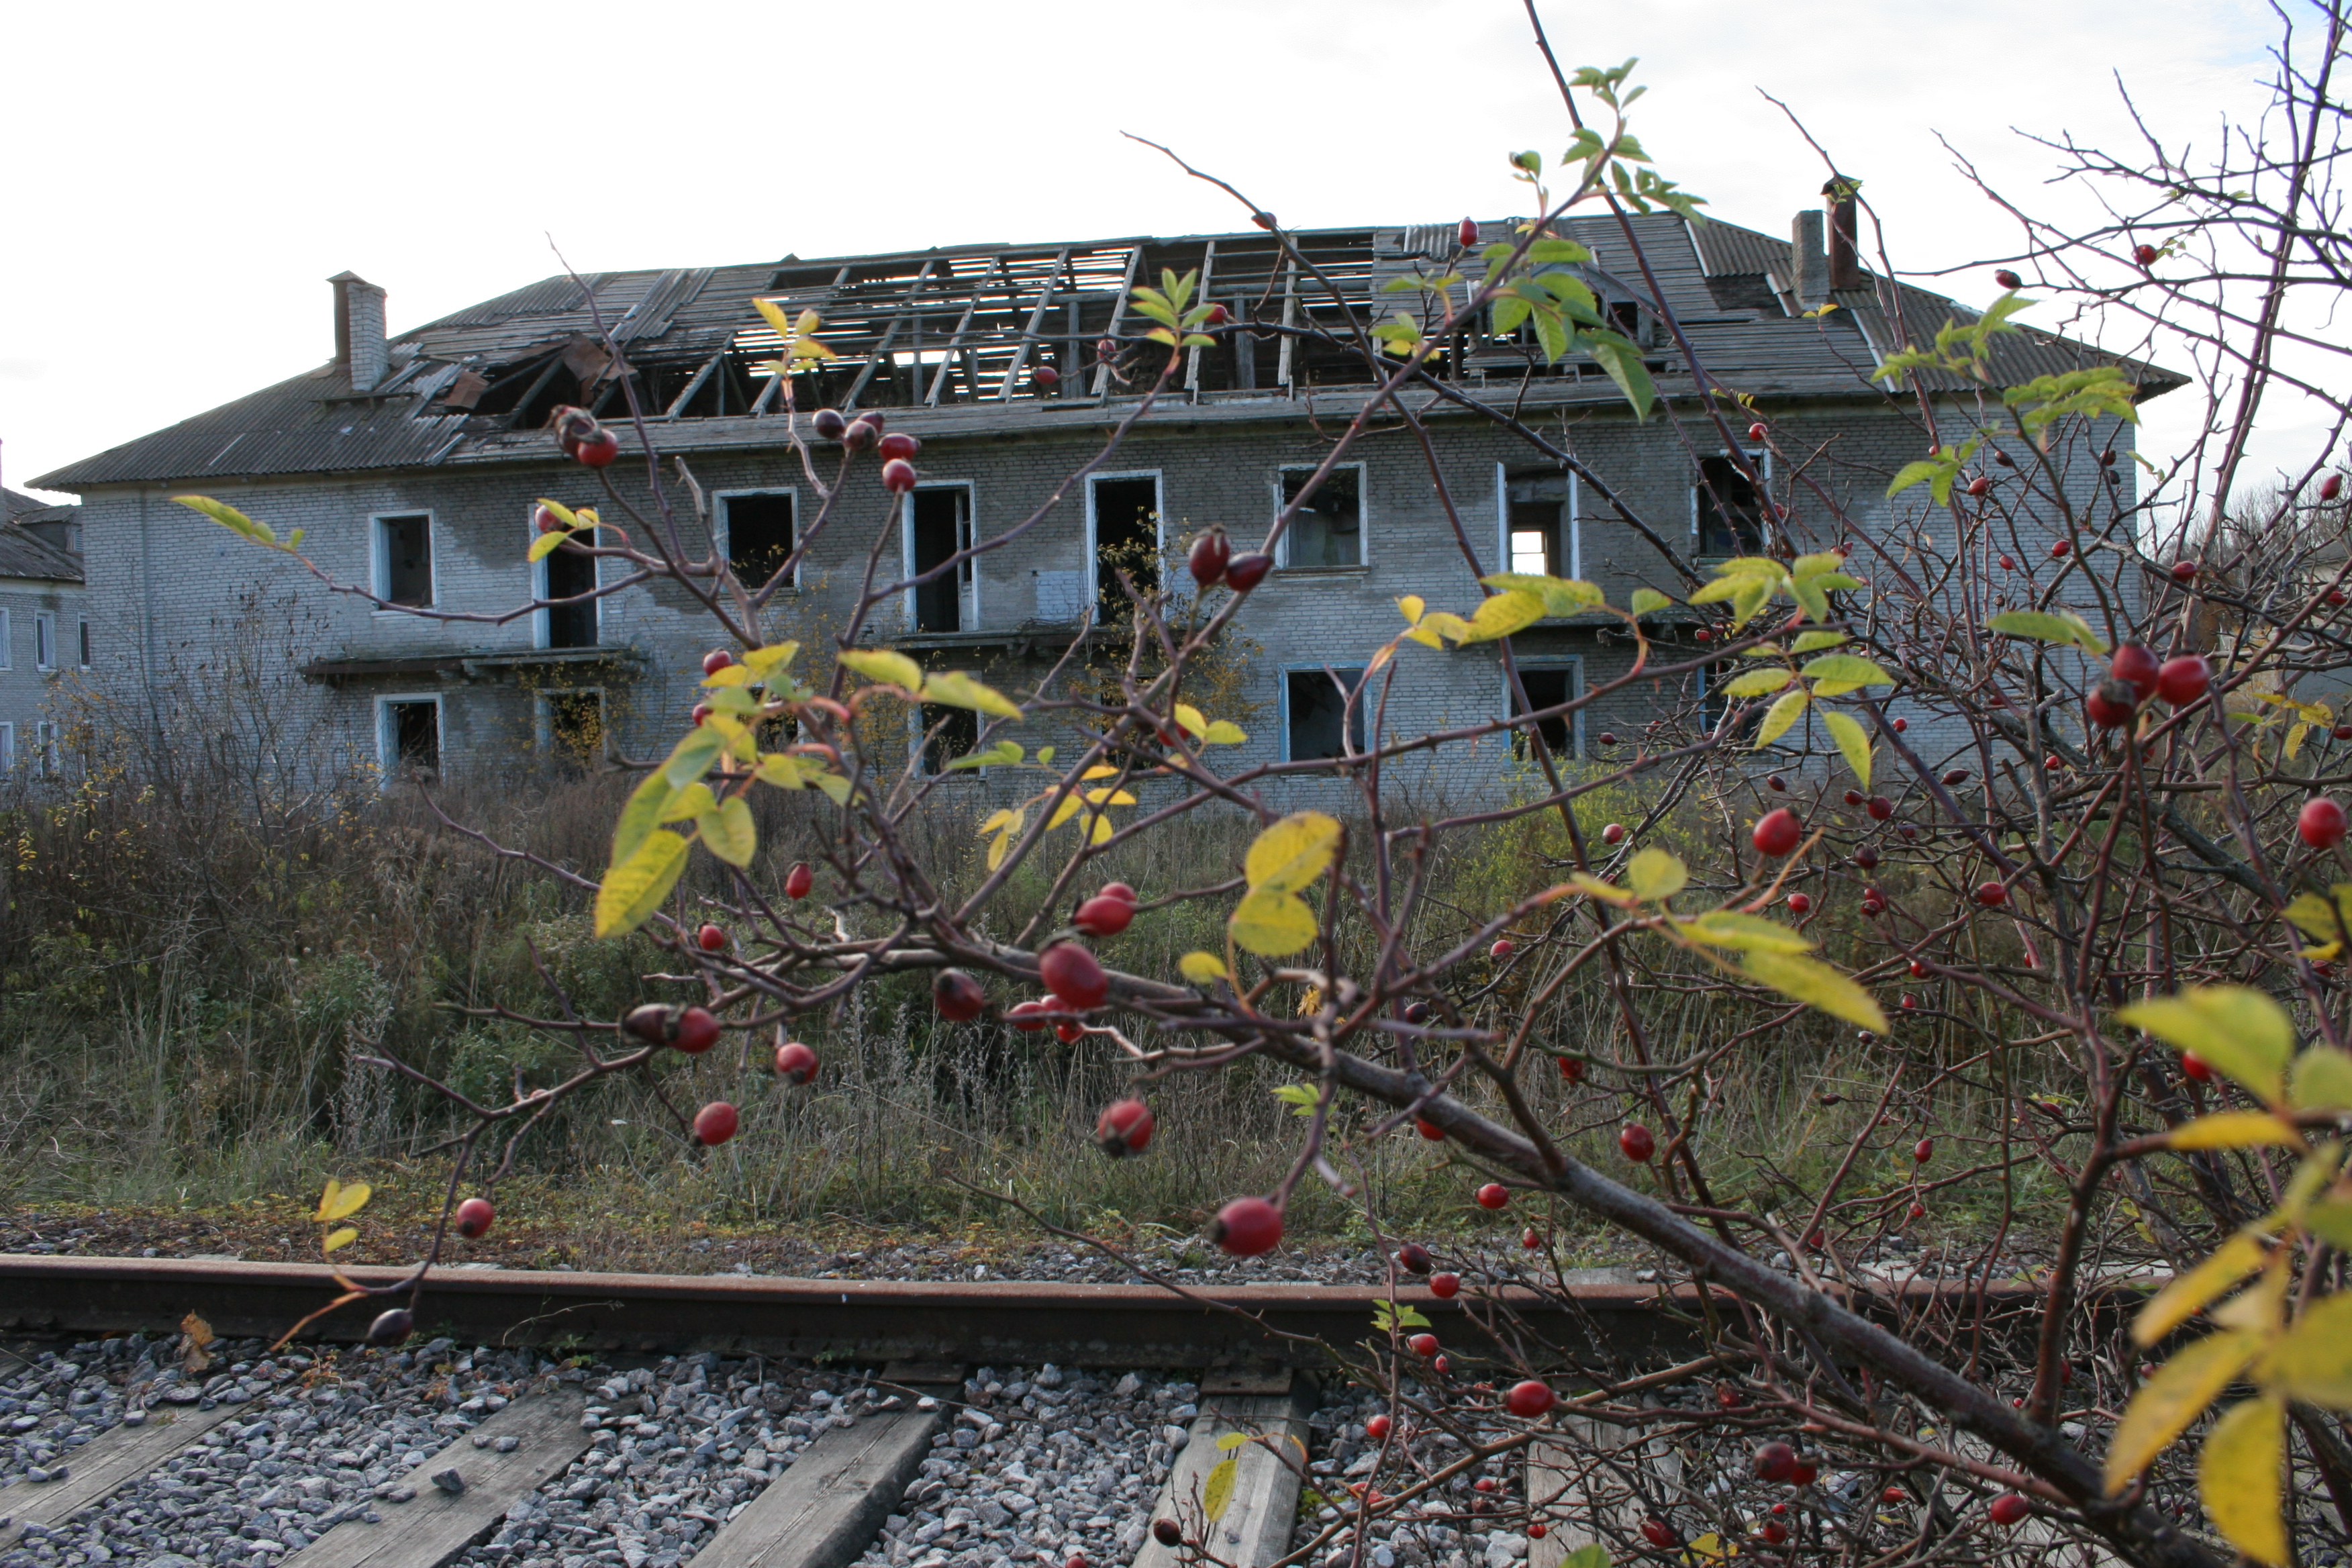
[0,1255,2041,1568]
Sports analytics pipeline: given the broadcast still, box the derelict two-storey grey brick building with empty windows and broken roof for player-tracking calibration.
[38,211,2169,799]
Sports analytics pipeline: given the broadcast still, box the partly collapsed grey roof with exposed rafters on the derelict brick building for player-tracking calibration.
[38,214,2180,491]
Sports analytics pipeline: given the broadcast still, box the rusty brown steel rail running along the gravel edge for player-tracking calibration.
[0,1253,2079,1366]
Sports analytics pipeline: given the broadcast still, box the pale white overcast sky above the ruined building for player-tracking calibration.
[0,0,2310,503]
